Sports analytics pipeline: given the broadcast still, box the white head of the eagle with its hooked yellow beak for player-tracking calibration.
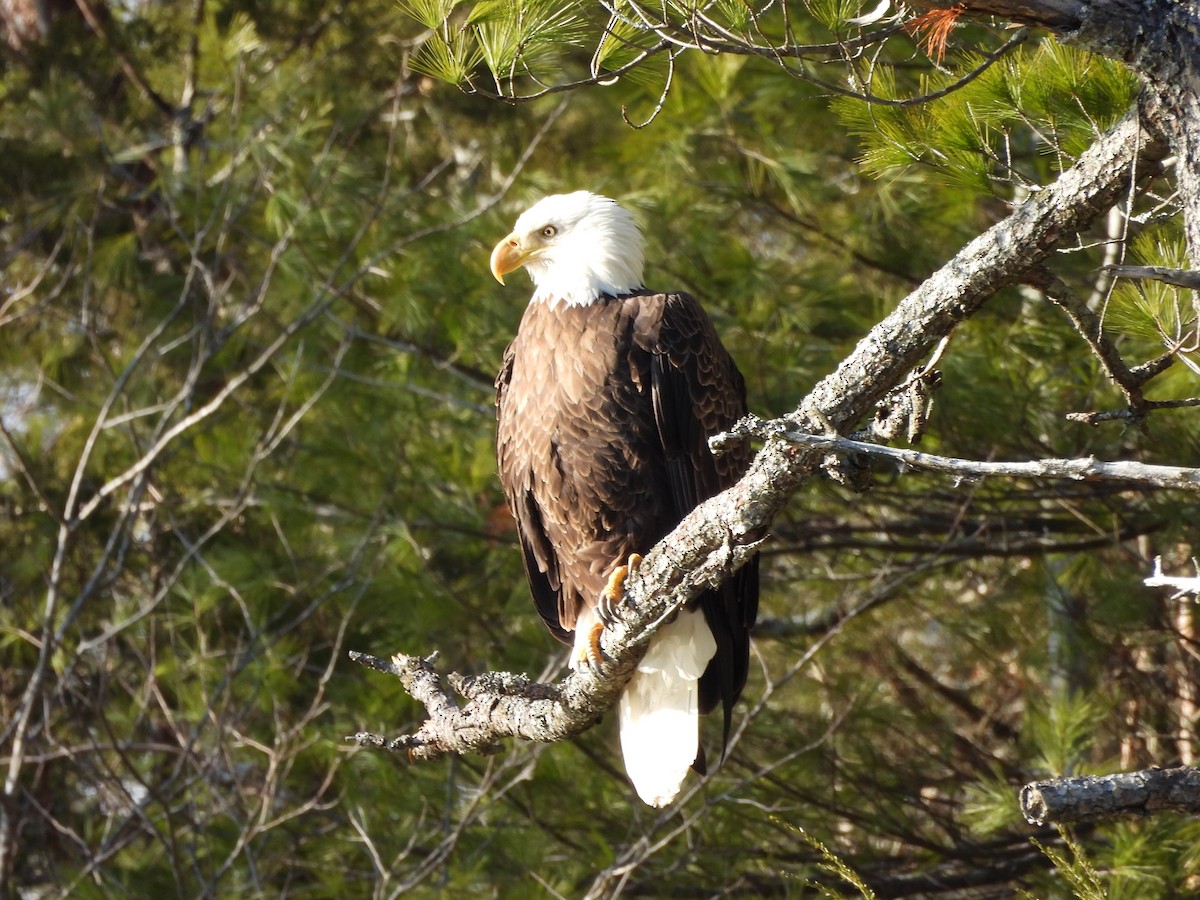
[492,191,644,306]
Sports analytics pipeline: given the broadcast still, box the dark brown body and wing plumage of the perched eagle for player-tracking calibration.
[496,293,758,731]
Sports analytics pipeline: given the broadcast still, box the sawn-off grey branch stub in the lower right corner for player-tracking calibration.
[1021,766,1200,826]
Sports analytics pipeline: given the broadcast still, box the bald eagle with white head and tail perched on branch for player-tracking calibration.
[491,191,758,806]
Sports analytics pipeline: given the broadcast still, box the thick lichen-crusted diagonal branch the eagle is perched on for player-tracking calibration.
[350,115,1163,760]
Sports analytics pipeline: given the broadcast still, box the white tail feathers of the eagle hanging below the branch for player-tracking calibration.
[620,610,716,806]
